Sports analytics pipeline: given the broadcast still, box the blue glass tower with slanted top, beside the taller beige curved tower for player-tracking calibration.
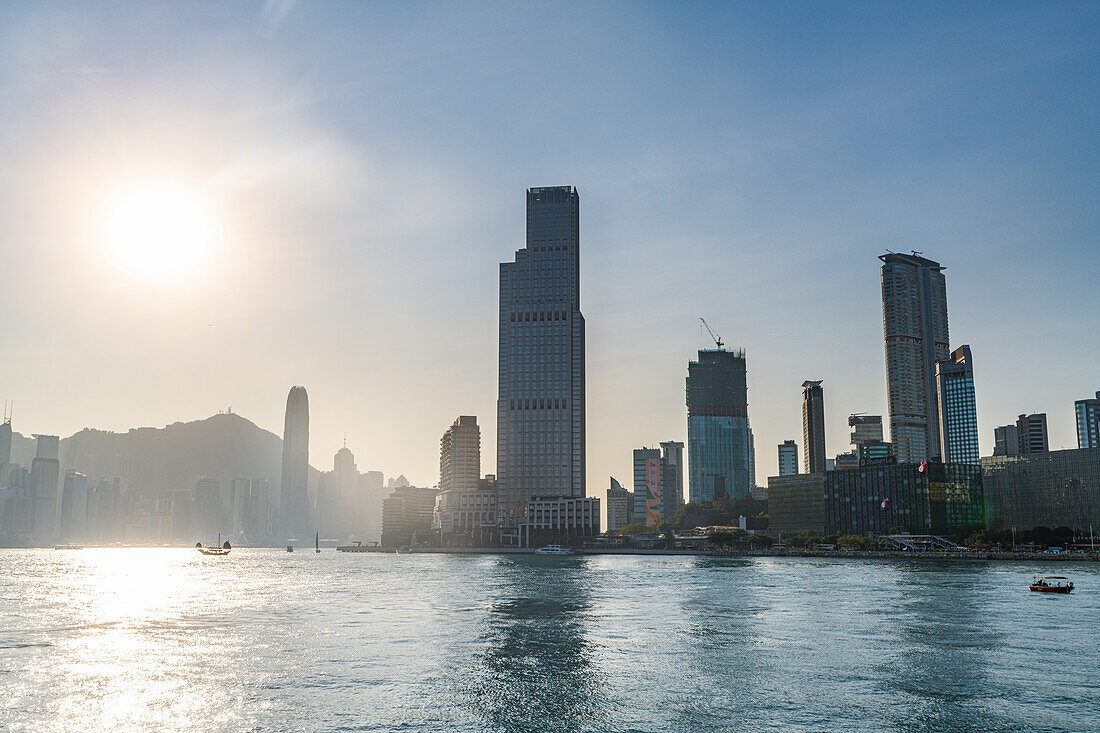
[936,346,981,466]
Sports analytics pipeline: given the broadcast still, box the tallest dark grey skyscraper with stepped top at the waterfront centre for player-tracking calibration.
[496,186,585,527]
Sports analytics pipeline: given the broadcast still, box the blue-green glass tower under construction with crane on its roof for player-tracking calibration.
[688,349,756,502]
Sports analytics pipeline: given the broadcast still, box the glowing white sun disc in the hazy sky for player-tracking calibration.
[103,184,217,282]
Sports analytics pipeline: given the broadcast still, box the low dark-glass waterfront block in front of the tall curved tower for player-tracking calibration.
[825,462,985,535]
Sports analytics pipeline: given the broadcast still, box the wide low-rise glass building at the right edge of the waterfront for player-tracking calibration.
[981,448,1100,533]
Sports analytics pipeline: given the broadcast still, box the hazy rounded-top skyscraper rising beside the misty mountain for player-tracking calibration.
[279,386,314,540]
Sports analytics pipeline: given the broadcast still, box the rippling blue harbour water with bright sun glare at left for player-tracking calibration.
[0,548,1100,733]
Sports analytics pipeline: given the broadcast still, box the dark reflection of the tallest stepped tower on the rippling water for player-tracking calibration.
[469,557,605,731]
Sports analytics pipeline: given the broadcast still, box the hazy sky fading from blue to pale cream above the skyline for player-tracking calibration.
[0,0,1100,495]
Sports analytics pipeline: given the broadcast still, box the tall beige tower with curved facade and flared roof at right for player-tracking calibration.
[879,252,949,462]
